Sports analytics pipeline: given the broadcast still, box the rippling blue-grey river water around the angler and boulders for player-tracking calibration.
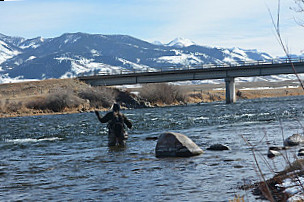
[0,96,304,201]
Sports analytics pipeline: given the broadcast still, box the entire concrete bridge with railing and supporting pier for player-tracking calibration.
[78,58,304,104]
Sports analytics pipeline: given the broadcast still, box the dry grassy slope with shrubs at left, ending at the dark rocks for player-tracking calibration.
[0,79,114,117]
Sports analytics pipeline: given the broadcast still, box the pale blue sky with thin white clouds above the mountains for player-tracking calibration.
[0,0,304,56]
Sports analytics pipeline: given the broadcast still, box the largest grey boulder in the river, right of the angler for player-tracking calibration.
[155,132,203,157]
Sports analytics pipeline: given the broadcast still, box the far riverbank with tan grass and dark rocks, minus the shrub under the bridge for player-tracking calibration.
[0,79,304,118]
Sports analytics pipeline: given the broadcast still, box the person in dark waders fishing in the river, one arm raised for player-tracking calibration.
[95,104,132,146]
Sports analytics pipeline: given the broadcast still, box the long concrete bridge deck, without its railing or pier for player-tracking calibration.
[78,61,304,86]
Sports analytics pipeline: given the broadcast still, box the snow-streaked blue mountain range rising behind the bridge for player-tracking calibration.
[0,33,272,83]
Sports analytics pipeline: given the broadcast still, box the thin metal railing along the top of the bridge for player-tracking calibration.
[79,57,304,76]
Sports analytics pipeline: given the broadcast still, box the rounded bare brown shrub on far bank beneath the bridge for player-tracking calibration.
[139,83,186,104]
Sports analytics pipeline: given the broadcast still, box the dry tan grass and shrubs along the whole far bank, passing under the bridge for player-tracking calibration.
[0,79,304,117]
